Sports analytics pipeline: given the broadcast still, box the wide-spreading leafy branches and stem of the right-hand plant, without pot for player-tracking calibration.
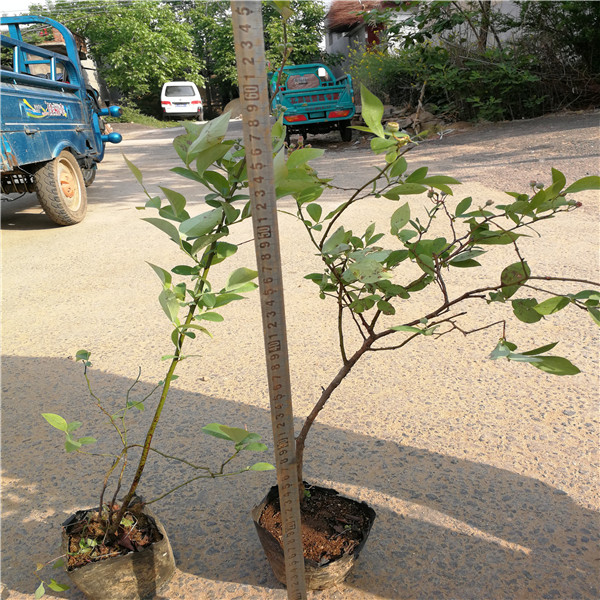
[277,87,600,494]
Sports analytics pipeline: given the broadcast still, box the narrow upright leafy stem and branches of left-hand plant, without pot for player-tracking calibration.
[42,113,273,589]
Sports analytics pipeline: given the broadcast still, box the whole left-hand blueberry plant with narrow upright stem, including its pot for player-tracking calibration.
[35,114,273,600]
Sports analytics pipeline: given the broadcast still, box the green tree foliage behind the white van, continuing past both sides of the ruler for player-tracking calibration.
[31,0,325,111]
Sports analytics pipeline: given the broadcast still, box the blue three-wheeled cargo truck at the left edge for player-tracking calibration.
[0,16,121,225]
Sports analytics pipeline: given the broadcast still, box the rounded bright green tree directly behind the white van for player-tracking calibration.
[31,0,203,105]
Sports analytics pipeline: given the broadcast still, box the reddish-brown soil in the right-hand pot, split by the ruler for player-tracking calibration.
[259,486,369,565]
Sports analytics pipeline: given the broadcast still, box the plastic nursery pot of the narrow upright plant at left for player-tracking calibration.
[62,507,175,600]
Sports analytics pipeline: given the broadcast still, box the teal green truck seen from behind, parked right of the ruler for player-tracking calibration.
[269,63,356,142]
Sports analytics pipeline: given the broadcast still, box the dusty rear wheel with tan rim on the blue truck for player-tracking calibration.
[34,150,87,225]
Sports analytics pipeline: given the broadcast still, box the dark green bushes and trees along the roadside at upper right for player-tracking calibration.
[352,0,600,120]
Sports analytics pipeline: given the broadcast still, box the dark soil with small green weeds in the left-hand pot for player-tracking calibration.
[66,504,163,571]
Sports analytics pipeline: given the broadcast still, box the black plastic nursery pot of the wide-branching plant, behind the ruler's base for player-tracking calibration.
[252,483,376,590]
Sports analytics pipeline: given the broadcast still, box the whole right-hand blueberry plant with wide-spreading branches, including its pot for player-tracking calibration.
[247,87,600,589]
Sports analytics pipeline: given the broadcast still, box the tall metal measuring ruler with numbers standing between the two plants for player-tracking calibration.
[231,0,306,600]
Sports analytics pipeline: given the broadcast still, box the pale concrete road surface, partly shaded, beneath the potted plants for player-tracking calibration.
[1,111,600,600]
